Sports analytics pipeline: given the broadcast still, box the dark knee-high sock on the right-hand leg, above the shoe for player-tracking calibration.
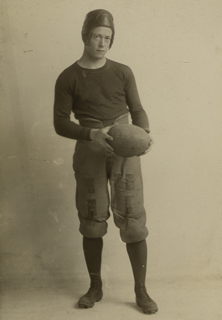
[126,240,147,286]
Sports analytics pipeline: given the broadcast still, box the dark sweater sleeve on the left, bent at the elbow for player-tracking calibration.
[54,75,91,140]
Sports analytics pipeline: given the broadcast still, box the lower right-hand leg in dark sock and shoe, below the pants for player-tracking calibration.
[126,240,158,314]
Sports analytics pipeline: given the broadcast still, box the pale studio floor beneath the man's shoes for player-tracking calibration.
[0,279,222,320]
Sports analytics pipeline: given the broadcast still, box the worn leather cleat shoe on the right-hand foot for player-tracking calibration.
[135,286,158,314]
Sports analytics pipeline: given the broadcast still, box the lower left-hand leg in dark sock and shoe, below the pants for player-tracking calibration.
[78,237,103,308]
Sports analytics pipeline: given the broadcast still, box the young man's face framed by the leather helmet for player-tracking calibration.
[85,27,112,59]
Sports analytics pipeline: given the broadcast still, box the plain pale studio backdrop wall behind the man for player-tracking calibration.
[0,0,222,318]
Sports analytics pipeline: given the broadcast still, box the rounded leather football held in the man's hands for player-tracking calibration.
[107,124,150,157]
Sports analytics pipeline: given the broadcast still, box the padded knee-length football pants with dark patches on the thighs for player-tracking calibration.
[73,115,148,243]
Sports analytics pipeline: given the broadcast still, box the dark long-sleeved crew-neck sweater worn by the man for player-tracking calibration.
[54,59,149,140]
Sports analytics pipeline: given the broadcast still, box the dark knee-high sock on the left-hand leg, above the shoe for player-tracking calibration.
[83,237,103,285]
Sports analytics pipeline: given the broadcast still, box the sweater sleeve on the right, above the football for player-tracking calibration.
[126,69,150,133]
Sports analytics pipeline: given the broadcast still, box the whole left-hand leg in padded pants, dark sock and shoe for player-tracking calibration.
[73,138,110,308]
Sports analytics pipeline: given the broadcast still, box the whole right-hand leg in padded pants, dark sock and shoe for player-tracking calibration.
[110,152,158,314]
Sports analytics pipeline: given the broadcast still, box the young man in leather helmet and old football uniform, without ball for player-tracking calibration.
[54,9,158,314]
